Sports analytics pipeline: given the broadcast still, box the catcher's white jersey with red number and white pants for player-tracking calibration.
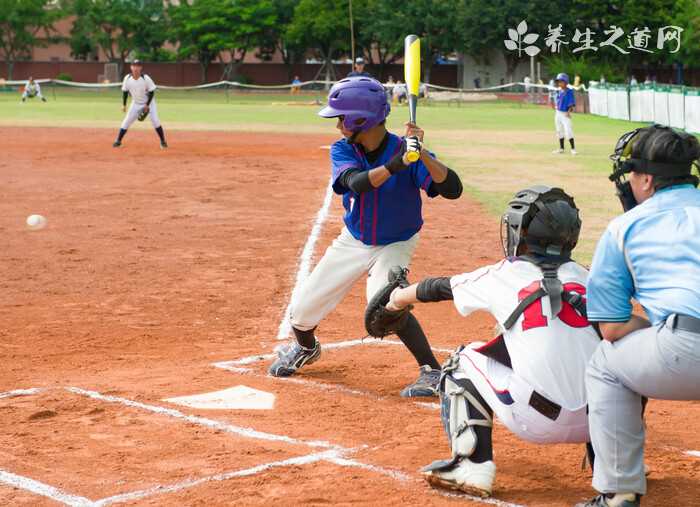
[450,258,600,443]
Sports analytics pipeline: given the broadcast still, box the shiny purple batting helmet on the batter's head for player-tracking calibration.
[318,76,391,132]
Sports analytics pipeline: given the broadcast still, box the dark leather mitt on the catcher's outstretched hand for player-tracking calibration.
[365,266,413,338]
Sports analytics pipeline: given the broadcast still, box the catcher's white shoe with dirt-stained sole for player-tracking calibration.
[422,458,496,498]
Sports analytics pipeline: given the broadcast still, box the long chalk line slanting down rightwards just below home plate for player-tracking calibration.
[65,387,344,452]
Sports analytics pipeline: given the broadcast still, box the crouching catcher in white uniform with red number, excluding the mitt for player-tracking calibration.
[386,186,600,496]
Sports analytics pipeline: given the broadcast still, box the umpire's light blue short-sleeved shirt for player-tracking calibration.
[587,185,700,325]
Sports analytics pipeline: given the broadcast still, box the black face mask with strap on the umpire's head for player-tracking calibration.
[609,125,692,211]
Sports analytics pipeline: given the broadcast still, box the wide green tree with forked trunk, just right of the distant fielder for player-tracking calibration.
[168,0,276,82]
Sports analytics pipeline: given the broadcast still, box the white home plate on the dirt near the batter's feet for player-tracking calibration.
[164,386,275,410]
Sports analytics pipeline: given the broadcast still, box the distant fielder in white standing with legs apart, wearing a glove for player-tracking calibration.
[112,60,168,148]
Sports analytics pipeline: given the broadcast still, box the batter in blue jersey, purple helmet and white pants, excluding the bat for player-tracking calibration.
[269,76,462,396]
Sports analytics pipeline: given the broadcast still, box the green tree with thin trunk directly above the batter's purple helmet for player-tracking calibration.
[286,0,350,81]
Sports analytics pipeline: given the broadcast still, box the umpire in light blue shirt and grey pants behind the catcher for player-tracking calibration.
[581,125,700,507]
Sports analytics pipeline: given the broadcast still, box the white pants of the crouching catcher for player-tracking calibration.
[454,343,597,444]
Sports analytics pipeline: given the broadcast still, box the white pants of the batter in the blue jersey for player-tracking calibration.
[290,227,418,331]
